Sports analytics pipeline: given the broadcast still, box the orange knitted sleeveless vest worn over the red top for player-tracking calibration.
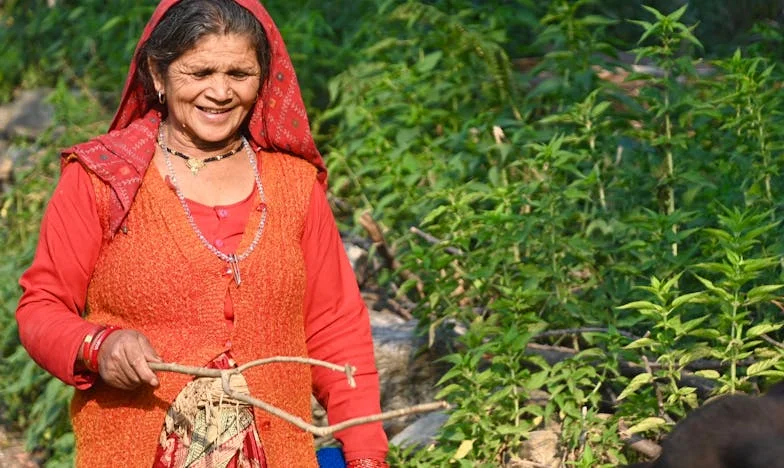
[71,153,316,468]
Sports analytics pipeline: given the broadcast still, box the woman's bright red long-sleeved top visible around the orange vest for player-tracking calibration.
[17,164,387,460]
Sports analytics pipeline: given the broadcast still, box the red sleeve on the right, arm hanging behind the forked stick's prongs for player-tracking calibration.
[302,185,387,461]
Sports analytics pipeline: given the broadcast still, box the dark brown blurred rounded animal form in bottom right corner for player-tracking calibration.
[627,382,784,468]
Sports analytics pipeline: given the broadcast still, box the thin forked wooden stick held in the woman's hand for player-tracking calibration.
[149,356,449,437]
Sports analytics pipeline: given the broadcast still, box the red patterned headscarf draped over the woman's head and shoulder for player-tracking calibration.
[62,0,327,234]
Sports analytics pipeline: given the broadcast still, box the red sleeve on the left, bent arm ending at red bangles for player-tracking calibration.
[16,164,101,388]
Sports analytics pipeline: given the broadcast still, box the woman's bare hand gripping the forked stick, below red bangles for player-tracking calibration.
[98,330,163,390]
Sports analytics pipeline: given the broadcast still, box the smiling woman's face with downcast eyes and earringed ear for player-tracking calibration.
[149,34,261,150]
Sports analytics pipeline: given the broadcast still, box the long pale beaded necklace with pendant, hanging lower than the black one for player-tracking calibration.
[158,121,267,286]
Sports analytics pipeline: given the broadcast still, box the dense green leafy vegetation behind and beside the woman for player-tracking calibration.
[0,0,784,467]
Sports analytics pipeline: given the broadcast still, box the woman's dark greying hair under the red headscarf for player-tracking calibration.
[137,0,272,104]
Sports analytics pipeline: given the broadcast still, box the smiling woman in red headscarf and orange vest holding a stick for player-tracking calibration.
[17,0,387,468]
